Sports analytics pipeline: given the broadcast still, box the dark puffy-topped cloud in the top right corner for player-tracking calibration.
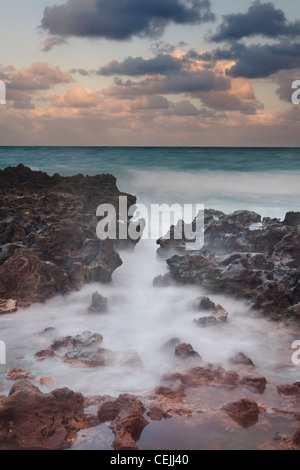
[211,1,300,42]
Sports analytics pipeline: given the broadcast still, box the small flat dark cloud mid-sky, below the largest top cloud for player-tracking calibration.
[97,54,182,76]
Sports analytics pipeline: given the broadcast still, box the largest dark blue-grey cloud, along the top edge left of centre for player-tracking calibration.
[41,0,215,40]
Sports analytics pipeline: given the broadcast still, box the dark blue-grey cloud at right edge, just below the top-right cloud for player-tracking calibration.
[220,42,300,78]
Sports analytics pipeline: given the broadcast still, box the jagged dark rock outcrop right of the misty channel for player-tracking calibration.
[155,210,300,320]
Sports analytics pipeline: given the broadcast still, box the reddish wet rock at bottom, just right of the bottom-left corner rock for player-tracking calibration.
[98,394,149,450]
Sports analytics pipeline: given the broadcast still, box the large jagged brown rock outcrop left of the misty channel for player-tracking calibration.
[0,165,136,307]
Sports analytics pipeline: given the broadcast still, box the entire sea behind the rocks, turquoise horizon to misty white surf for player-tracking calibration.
[0,147,300,217]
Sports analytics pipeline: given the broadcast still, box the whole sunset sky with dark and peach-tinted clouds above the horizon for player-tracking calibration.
[0,0,300,147]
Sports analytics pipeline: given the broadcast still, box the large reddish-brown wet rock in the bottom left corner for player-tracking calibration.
[0,379,88,450]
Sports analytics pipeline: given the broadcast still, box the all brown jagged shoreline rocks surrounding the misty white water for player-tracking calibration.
[0,165,300,450]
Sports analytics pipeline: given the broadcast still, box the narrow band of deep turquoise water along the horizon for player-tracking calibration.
[0,147,300,175]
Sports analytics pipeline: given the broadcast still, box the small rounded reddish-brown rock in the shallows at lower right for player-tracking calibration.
[223,398,260,427]
